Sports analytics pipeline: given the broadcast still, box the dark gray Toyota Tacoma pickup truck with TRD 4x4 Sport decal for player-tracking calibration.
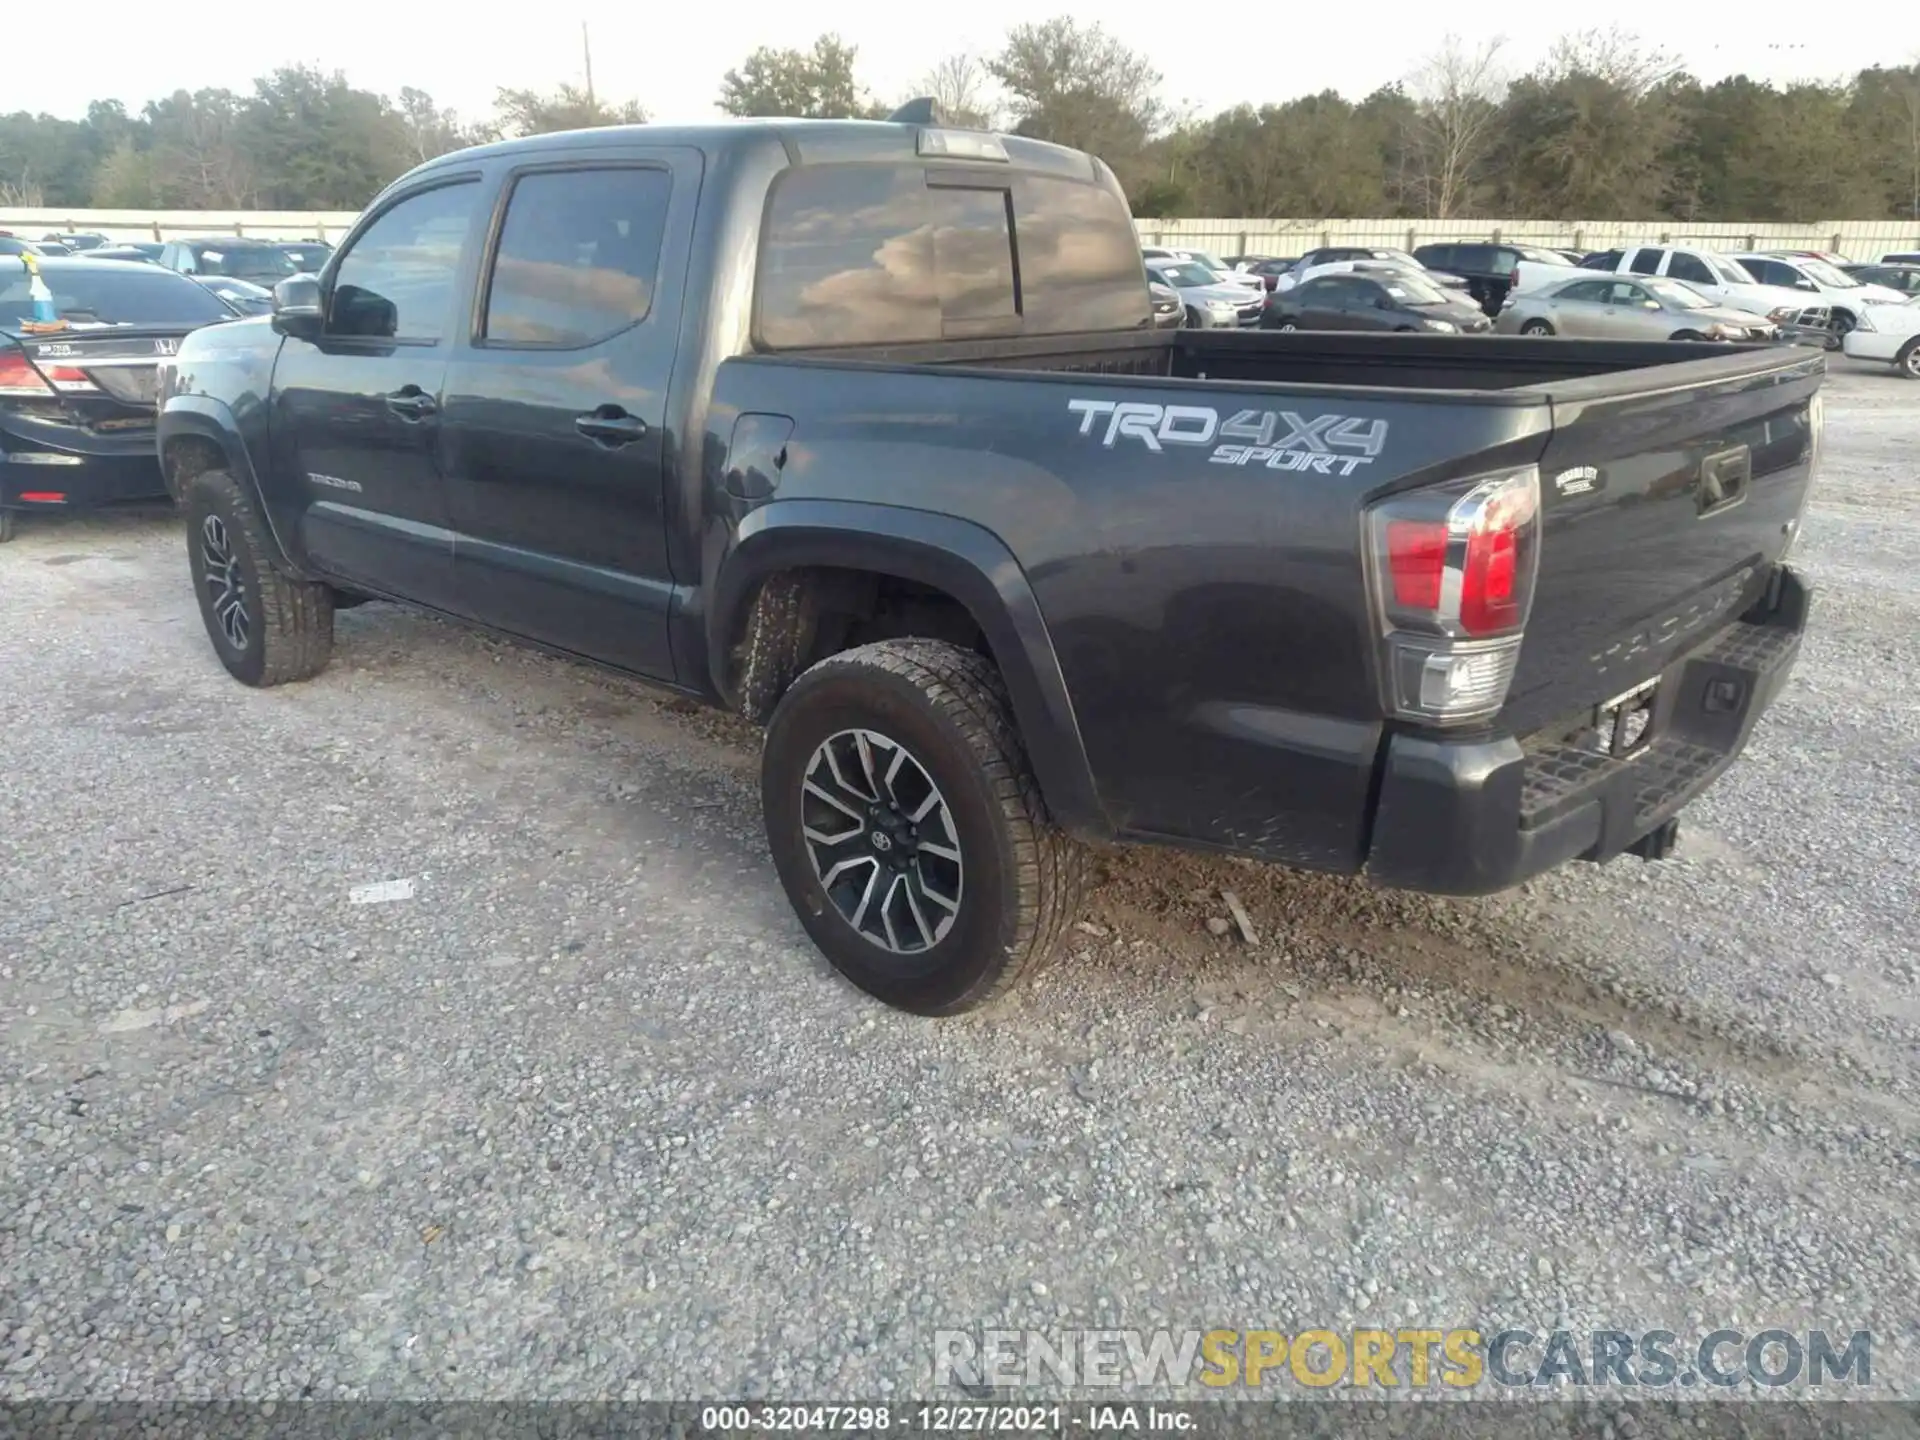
[159,104,1824,1014]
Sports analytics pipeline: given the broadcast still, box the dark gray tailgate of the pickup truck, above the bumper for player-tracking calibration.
[1501,351,1826,735]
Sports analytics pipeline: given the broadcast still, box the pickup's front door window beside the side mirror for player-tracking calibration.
[326,180,480,342]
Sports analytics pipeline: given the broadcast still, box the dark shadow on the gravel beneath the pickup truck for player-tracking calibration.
[319,605,1896,1136]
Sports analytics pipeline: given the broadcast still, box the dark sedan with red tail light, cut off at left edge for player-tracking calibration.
[0,255,234,540]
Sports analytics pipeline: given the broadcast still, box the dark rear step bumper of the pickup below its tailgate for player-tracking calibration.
[1367,566,1811,895]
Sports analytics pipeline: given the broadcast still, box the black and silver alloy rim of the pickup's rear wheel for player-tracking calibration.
[801,730,966,954]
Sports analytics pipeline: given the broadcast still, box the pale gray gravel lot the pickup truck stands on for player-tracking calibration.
[0,361,1920,1398]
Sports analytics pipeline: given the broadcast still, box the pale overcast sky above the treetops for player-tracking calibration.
[15,0,1920,121]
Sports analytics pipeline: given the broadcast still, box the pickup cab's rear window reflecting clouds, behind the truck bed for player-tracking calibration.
[755,165,1150,349]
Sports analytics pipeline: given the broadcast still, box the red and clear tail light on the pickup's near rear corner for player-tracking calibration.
[1367,465,1540,726]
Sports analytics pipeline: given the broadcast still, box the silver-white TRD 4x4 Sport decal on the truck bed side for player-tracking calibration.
[1068,399,1386,474]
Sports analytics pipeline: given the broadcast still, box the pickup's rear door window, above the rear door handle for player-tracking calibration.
[482,167,674,349]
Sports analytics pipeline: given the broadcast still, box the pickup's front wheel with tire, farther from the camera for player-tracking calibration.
[184,470,334,687]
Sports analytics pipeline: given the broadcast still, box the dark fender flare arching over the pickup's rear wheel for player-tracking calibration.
[707,499,1114,839]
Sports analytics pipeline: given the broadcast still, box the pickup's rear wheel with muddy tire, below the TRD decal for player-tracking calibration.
[760,639,1085,1016]
